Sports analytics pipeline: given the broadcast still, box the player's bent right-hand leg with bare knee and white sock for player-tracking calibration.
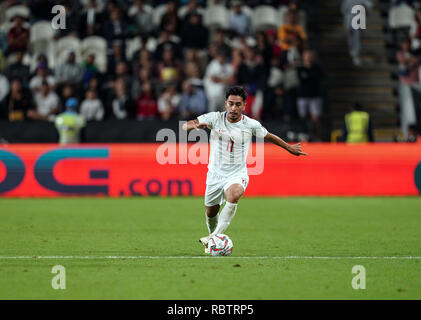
[211,178,248,236]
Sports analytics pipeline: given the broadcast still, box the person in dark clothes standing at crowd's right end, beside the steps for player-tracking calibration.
[297,50,323,137]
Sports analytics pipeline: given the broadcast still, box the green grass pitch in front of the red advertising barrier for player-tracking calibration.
[0,197,421,300]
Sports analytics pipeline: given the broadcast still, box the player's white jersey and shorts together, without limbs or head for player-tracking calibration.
[197,112,268,206]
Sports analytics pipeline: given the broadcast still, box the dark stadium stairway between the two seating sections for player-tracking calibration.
[315,0,399,141]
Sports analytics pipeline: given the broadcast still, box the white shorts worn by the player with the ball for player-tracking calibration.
[205,172,249,207]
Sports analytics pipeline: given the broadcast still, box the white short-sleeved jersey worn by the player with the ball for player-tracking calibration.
[197,112,268,177]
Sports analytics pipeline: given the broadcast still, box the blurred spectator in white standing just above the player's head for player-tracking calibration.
[204,48,234,112]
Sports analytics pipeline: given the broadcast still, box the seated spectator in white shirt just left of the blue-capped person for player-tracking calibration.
[27,81,60,121]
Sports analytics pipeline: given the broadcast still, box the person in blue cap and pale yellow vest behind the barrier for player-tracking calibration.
[54,98,85,144]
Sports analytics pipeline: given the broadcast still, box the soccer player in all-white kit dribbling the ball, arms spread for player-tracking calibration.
[183,86,306,253]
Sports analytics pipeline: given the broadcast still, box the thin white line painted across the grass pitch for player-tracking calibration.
[0,256,421,260]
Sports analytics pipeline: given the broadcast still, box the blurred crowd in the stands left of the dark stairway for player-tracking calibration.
[0,0,323,139]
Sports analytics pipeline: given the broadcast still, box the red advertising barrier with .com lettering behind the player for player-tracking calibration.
[0,143,421,197]
